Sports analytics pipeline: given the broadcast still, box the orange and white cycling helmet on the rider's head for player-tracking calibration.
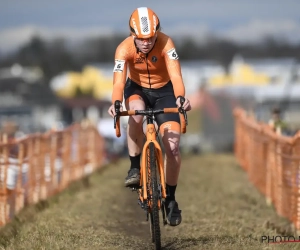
[129,7,160,38]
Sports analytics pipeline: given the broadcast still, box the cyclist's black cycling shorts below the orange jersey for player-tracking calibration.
[124,78,180,128]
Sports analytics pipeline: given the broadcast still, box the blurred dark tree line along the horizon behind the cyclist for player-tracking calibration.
[0,35,300,80]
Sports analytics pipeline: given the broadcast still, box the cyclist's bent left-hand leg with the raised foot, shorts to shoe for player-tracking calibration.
[124,79,149,186]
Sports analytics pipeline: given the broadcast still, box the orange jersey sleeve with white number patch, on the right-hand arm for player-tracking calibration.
[163,38,185,98]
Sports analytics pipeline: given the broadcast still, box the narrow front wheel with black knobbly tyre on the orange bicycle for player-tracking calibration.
[147,142,161,250]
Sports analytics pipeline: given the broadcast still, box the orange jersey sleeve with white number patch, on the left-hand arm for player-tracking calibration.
[112,44,127,103]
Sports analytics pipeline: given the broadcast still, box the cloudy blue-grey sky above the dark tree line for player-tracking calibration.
[0,0,300,52]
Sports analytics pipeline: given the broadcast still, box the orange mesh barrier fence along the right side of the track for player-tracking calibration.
[234,108,300,230]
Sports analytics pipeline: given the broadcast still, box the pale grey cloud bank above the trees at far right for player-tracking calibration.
[219,20,300,43]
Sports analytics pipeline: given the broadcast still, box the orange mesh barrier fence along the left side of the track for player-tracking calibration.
[0,124,105,226]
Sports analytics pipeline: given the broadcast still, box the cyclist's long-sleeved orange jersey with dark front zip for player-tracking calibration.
[112,32,185,103]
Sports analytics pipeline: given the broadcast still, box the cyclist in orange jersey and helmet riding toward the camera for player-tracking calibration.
[108,7,191,226]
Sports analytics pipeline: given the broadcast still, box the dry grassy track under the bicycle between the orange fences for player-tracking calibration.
[0,155,300,250]
